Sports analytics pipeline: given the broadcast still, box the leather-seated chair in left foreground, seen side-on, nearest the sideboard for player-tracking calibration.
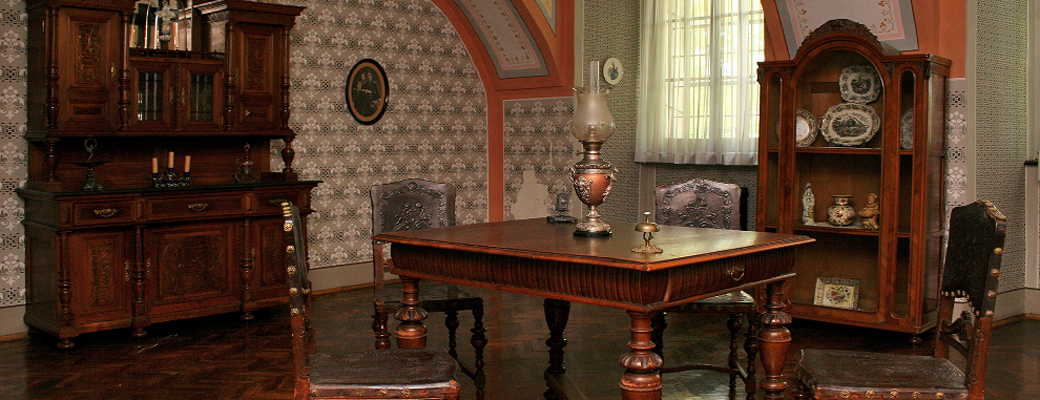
[282,202,460,400]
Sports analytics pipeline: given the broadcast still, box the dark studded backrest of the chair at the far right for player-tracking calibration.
[935,201,1008,399]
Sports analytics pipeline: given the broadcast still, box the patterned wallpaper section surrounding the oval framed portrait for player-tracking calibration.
[280,0,488,268]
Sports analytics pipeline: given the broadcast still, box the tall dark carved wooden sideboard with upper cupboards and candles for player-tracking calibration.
[18,0,318,347]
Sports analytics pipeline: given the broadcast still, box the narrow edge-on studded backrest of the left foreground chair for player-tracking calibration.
[282,202,314,399]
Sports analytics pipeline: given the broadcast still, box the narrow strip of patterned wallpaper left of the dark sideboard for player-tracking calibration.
[0,1,28,306]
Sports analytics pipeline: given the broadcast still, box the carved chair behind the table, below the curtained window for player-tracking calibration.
[651,179,758,400]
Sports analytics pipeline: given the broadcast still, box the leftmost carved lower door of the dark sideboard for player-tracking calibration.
[65,231,134,326]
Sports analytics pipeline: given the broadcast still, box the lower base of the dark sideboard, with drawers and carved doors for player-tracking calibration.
[19,181,317,347]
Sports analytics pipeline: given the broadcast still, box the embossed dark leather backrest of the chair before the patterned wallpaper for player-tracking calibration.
[371,179,456,235]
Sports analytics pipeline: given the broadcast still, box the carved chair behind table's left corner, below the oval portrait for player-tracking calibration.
[371,179,488,399]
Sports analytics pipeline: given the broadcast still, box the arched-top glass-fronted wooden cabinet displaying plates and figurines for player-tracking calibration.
[757,20,951,341]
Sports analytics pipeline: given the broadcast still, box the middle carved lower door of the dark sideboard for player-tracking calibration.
[144,221,242,315]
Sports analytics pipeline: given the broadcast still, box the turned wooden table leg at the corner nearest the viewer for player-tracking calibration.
[621,311,662,400]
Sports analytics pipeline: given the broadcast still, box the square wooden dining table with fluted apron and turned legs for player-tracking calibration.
[372,218,813,400]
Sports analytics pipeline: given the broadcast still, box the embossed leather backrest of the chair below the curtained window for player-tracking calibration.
[654,179,747,230]
